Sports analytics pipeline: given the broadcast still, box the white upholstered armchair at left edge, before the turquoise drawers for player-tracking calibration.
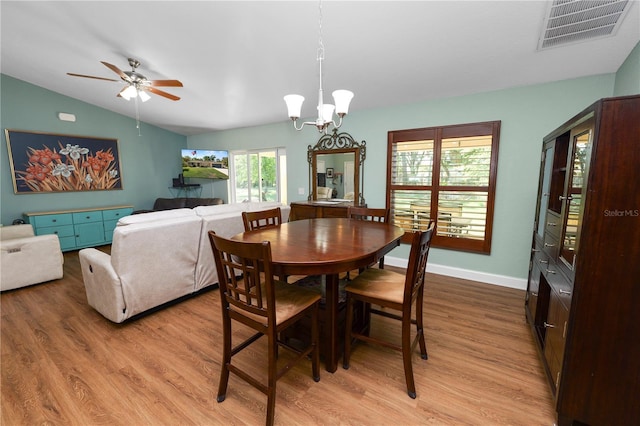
[0,224,64,291]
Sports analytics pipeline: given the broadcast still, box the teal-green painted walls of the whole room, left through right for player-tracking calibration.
[0,41,640,279]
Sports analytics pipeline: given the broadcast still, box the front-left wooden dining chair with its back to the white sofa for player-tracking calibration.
[209,231,320,425]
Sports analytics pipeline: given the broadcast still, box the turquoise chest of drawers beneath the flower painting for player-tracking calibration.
[23,206,133,251]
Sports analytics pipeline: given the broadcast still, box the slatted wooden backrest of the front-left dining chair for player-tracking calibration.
[209,231,275,318]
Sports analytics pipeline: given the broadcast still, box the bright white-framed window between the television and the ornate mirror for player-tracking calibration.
[229,148,287,204]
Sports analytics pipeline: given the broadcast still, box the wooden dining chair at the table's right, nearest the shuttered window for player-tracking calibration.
[342,222,435,398]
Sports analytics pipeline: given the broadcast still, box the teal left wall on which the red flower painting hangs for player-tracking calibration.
[0,74,187,225]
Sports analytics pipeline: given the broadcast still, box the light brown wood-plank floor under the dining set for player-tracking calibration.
[0,248,555,426]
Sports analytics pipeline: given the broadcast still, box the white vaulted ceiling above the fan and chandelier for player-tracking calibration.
[0,0,640,135]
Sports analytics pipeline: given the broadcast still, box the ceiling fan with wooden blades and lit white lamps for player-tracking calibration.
[67,58,182,102]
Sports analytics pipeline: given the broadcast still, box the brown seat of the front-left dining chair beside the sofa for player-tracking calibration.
[234,280,320,327]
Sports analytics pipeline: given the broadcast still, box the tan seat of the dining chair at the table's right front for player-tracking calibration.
[345,268,405,306]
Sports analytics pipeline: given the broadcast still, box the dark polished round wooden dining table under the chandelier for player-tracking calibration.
[233,218,404,373]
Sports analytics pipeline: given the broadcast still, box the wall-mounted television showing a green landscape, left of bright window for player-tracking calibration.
[181,149,229,179]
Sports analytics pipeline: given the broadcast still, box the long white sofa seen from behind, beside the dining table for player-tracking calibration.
[79,203,290,323]
